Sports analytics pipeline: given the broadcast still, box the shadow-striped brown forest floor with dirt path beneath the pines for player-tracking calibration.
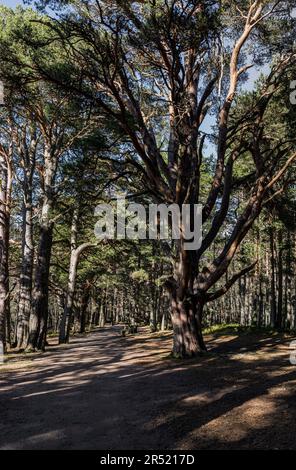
[0,327,296,450]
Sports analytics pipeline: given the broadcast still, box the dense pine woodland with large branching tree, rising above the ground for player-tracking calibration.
[0,0,296,357]
